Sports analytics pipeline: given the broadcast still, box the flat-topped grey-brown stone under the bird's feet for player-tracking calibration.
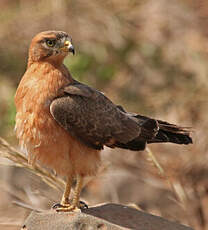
[22,204,193,230]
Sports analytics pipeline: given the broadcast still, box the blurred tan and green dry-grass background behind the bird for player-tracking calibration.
[0,0,208,230]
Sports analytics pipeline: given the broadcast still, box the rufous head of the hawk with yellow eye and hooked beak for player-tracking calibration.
[29,31,75,63]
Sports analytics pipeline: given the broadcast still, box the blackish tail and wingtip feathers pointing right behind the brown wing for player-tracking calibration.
[115,111,192,151]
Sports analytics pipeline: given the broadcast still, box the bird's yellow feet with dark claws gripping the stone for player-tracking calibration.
[52,201,88,212]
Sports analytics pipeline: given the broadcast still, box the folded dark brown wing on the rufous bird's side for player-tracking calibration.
[50,82,141,149]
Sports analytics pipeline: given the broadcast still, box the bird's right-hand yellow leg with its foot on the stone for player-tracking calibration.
[56,175,83,212]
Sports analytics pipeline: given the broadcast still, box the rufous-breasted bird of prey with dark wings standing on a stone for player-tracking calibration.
[15,31,192,211]
